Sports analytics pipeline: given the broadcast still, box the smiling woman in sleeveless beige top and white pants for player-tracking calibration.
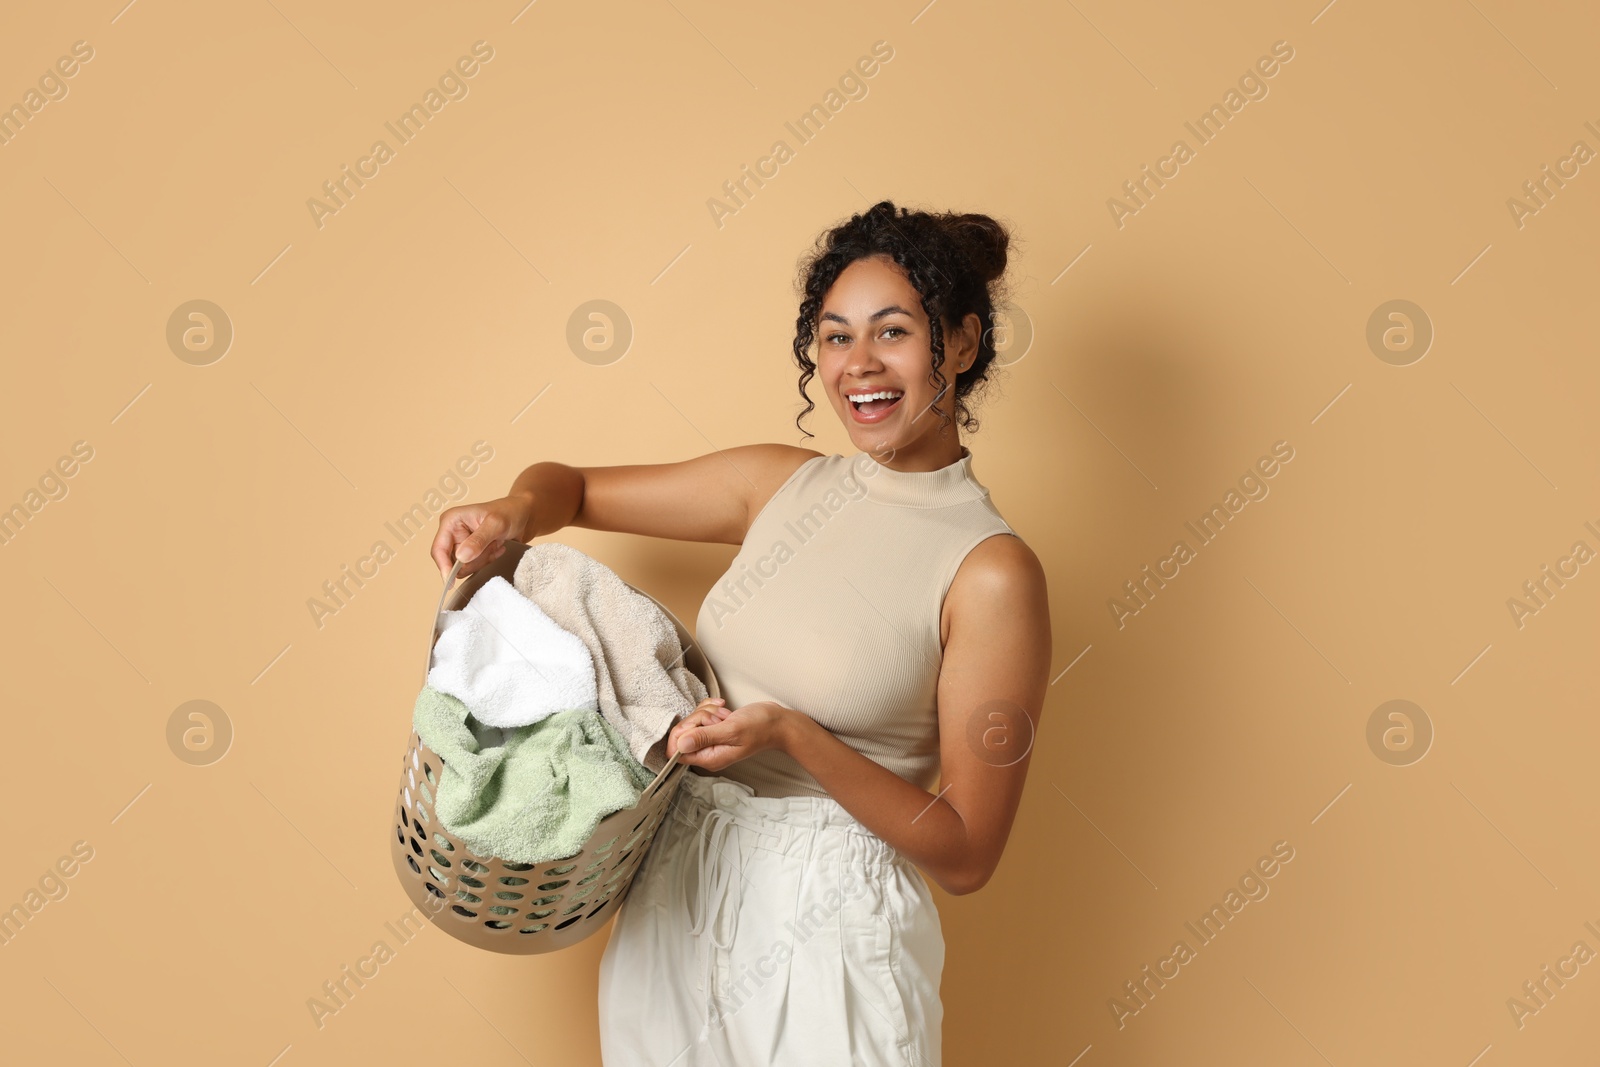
[434,202,1051,1067]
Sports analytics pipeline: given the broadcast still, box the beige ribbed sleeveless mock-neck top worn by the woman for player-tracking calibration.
[694,446,1016,797]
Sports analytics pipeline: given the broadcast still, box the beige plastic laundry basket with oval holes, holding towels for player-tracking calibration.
[389,541,720,955]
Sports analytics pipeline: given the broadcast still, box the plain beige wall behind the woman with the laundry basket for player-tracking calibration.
[0,0,1600,1067]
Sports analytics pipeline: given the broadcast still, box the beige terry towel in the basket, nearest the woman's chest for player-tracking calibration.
[512,541,707,773]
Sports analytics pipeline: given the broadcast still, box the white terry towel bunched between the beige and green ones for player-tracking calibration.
[427,576,598,729]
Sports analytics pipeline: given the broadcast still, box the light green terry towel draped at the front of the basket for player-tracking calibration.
[411,686,654,864]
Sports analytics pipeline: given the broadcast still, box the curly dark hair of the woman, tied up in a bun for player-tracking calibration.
[794,200,1011,437]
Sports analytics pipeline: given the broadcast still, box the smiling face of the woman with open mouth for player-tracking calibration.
[816,256,978,469]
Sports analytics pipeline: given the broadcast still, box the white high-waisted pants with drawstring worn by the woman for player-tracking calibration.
[600,768,944,1067]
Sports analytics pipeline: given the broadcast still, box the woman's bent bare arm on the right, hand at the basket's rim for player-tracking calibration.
[669,536,1051,896]
